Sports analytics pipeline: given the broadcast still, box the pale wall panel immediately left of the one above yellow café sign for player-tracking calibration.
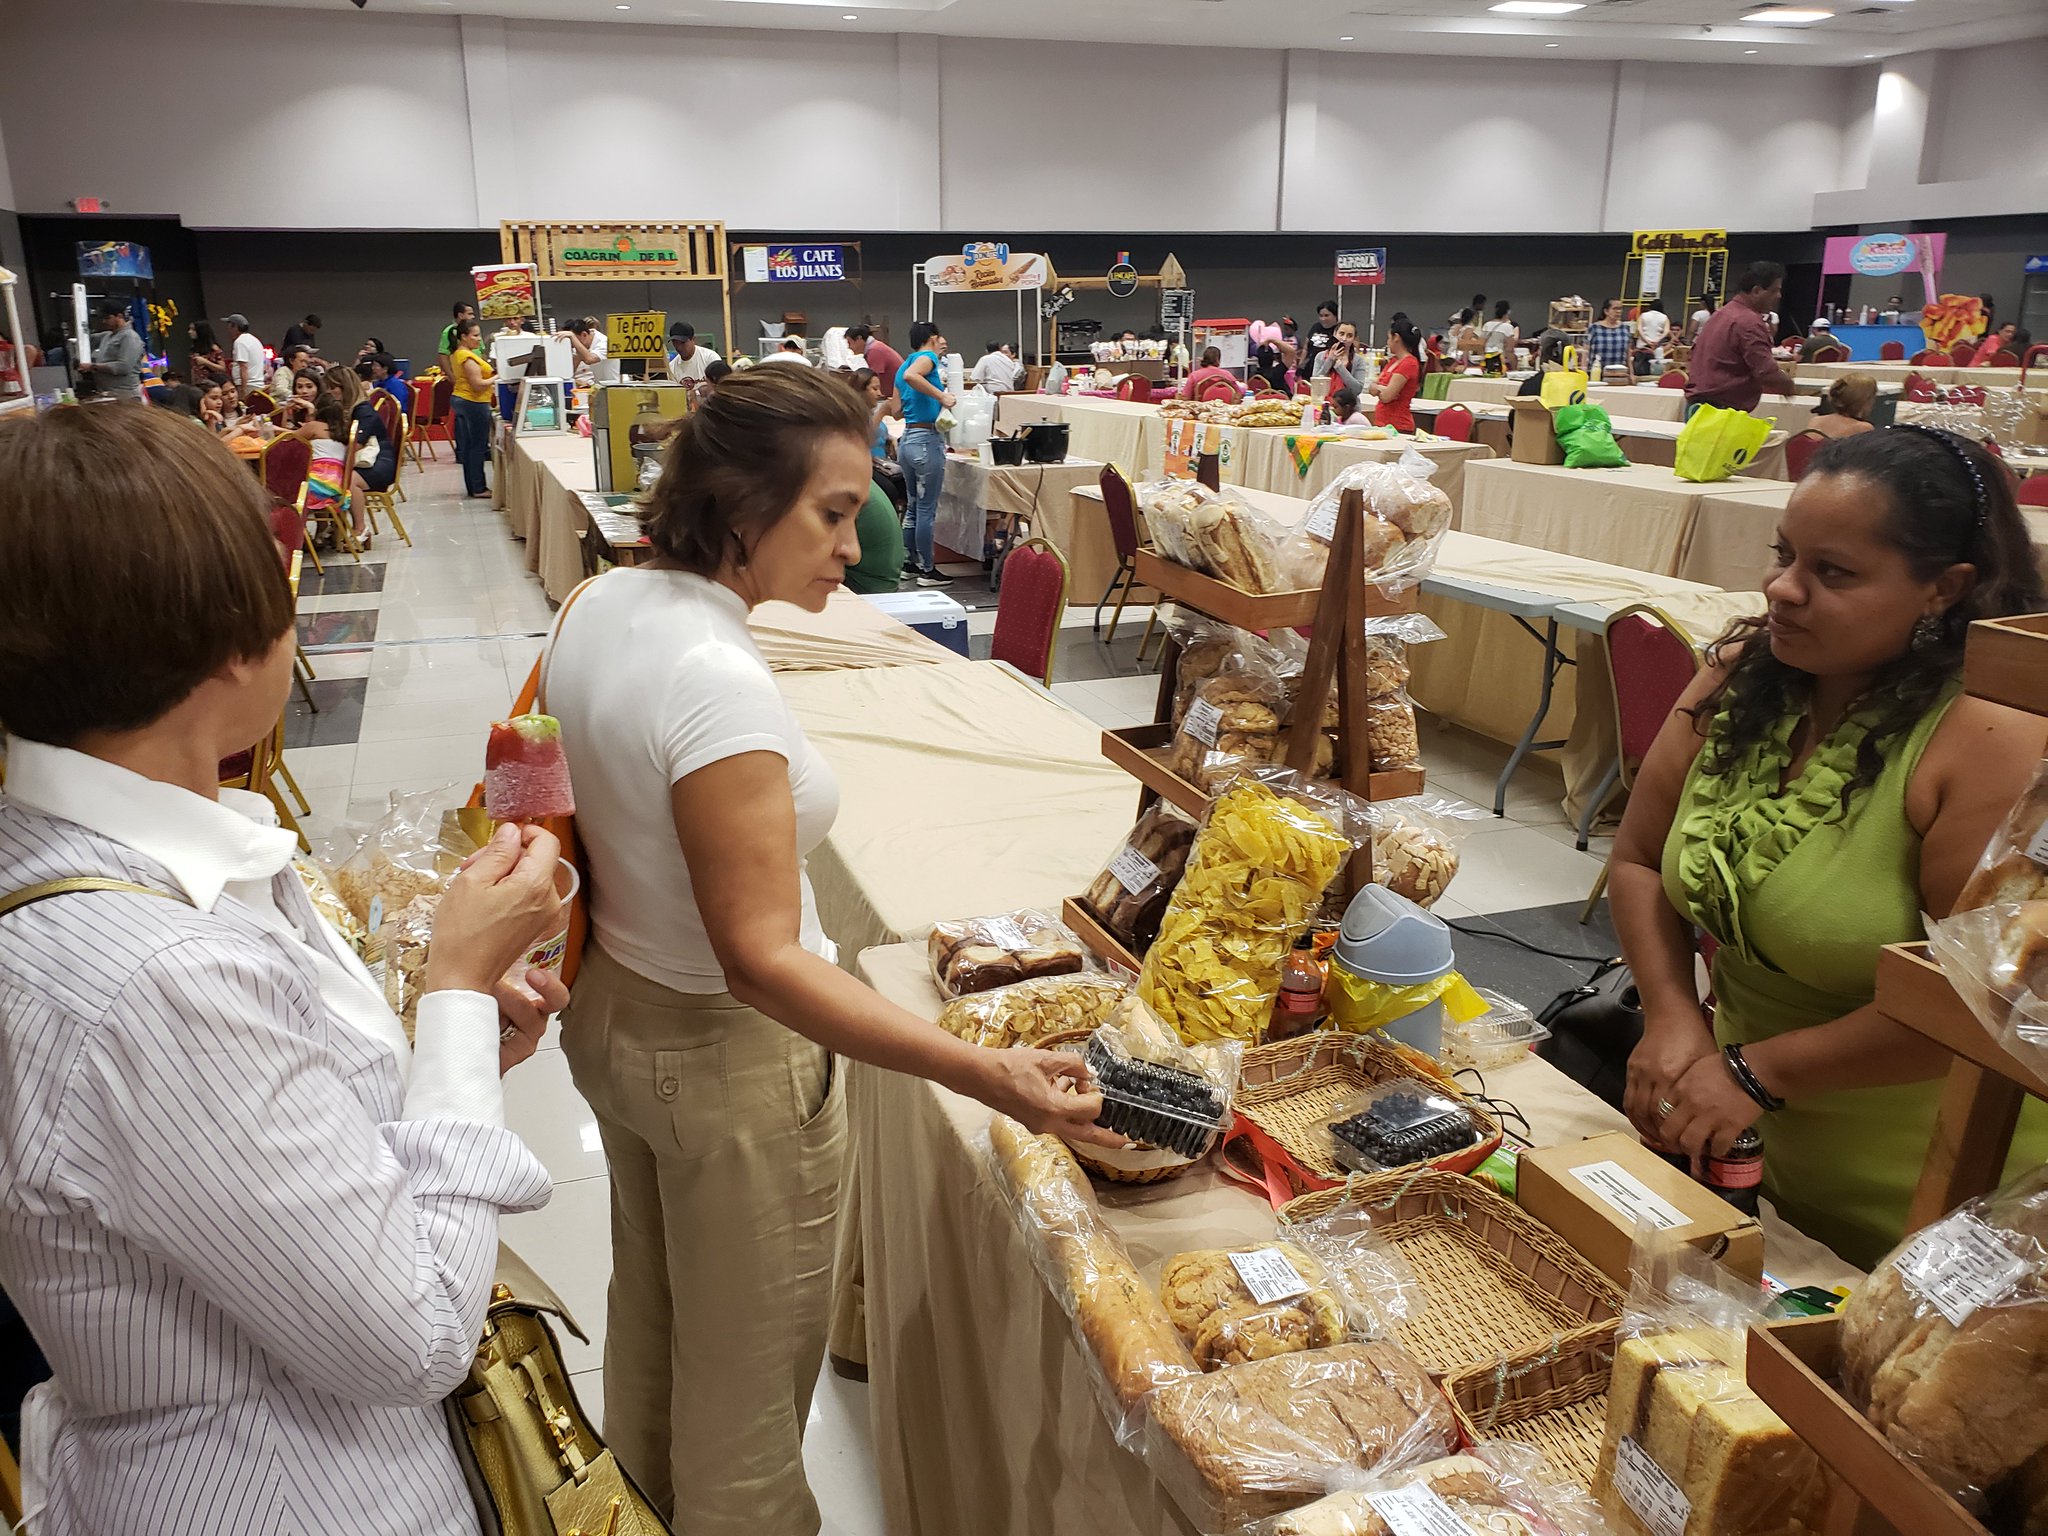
[1294,53,1614,233]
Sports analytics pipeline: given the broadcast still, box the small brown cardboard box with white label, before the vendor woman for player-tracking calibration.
[1516,1133,1763,1290]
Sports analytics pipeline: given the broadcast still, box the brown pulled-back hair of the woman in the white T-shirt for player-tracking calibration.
[641,362,868,575]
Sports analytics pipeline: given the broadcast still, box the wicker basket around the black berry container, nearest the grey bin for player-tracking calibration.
[1225,1030,1501,1198]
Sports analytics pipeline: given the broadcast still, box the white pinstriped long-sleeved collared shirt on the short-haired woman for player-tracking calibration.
[0,743,549,1536]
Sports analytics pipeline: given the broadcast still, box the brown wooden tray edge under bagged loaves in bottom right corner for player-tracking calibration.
[1747,1317,1987,1536]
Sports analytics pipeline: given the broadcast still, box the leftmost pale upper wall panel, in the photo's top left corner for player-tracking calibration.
[0,0,477,229]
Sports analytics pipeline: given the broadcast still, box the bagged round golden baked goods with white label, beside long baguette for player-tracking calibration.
[1159,1241,1348,1370]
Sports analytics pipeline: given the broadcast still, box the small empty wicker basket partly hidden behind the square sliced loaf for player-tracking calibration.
[1444,1323,1614,1489]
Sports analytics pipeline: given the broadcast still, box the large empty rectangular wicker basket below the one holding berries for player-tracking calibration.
[1280,1167,1622,1374]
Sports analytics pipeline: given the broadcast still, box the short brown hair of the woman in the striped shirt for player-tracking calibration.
[0,403,293,748]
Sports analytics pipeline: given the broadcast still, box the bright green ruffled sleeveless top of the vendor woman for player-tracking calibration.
[1663,682,2048,1270]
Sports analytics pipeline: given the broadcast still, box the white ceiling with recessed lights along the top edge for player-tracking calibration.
[167,0,2048,66]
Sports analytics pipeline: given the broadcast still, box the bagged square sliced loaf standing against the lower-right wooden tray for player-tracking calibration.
[1595,1329,1825,1536]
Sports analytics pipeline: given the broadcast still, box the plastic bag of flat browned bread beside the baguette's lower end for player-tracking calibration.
[1145,1341,1458,1536]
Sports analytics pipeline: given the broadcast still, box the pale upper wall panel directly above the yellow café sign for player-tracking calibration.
[1606,63,1860,229]
